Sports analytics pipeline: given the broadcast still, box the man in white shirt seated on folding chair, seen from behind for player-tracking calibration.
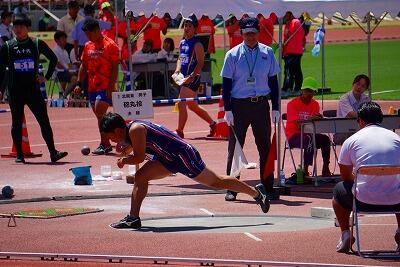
[332,102,400,253]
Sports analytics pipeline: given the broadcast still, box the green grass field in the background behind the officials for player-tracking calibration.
[212,40,400,100]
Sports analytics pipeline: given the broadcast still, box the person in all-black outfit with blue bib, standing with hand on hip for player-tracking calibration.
[0,15,68,163]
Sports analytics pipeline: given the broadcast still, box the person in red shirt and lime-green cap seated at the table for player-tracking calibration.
[285,77,332,176]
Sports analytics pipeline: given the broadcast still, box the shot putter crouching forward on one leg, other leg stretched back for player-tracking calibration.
[100,112,270,229]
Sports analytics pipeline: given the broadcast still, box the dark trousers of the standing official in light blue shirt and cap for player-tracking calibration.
[226,96,274,192]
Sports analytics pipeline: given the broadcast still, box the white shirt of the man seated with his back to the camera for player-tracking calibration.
[339,124,400,205]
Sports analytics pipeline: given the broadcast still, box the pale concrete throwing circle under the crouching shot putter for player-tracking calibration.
[120,215,334,233]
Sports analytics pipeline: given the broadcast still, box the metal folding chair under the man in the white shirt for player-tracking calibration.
[350,164,400,259]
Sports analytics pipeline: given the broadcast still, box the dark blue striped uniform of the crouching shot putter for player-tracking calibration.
[127,120,206,178]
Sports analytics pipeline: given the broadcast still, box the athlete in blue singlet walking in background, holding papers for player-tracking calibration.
[175,16,216,138]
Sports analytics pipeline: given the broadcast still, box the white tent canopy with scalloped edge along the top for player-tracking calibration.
[125,0,400,18]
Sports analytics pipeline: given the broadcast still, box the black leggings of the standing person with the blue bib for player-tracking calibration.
[9,87,56,155]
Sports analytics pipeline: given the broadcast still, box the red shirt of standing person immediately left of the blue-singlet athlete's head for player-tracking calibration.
[138,14,167,53]
